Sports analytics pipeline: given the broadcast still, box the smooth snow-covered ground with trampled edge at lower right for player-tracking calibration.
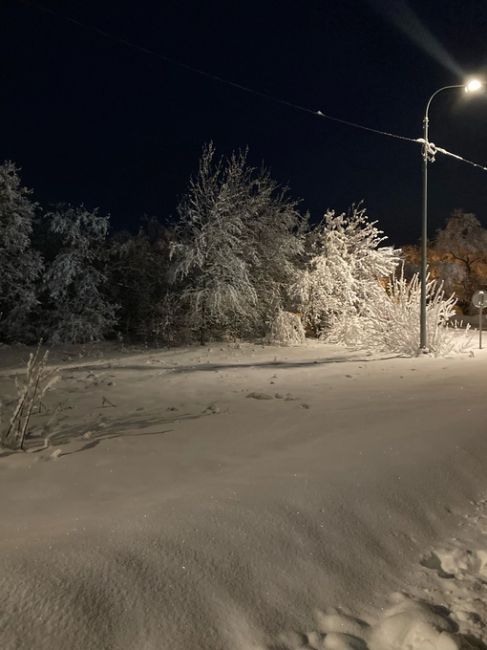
[0,344,487,650]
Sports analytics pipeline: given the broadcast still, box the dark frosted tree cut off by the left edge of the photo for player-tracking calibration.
[0,161,42,341]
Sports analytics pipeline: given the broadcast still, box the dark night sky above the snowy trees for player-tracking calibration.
[0,0,487,245]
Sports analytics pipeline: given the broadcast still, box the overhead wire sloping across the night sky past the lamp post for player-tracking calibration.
[14,0,487,171]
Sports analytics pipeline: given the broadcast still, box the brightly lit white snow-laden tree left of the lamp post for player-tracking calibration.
[293,207,398,335]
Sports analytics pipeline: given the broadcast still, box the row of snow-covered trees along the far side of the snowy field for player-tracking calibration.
[0,143,480,344]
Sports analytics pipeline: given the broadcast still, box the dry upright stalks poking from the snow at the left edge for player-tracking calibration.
[0,343,60,451]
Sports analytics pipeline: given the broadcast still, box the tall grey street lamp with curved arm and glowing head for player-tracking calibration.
[419,79,484,352]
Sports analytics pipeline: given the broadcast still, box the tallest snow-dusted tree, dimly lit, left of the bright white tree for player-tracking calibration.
[172,144,302,340]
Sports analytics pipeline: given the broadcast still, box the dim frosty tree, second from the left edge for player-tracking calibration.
[41,205,115,343]
